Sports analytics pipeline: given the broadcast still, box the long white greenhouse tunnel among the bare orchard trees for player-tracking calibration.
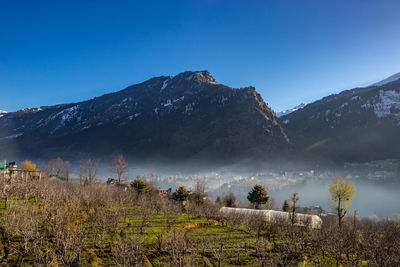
[219,207,322,229]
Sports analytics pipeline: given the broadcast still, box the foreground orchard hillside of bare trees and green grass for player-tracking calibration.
[0,175,400,266]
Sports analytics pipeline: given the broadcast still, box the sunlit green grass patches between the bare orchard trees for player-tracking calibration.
[0,199,266,266]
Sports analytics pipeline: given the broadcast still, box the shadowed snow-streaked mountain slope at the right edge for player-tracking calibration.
[280,75,400,162]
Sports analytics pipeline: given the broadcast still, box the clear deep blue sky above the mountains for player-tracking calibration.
[0,0,400,111]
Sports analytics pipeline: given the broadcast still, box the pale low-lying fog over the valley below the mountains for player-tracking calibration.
[29,160,400,219]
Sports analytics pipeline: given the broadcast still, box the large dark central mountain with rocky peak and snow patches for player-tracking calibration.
[0,71,290,161]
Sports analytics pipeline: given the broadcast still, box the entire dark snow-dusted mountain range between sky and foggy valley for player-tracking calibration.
[0,71,400,166]
